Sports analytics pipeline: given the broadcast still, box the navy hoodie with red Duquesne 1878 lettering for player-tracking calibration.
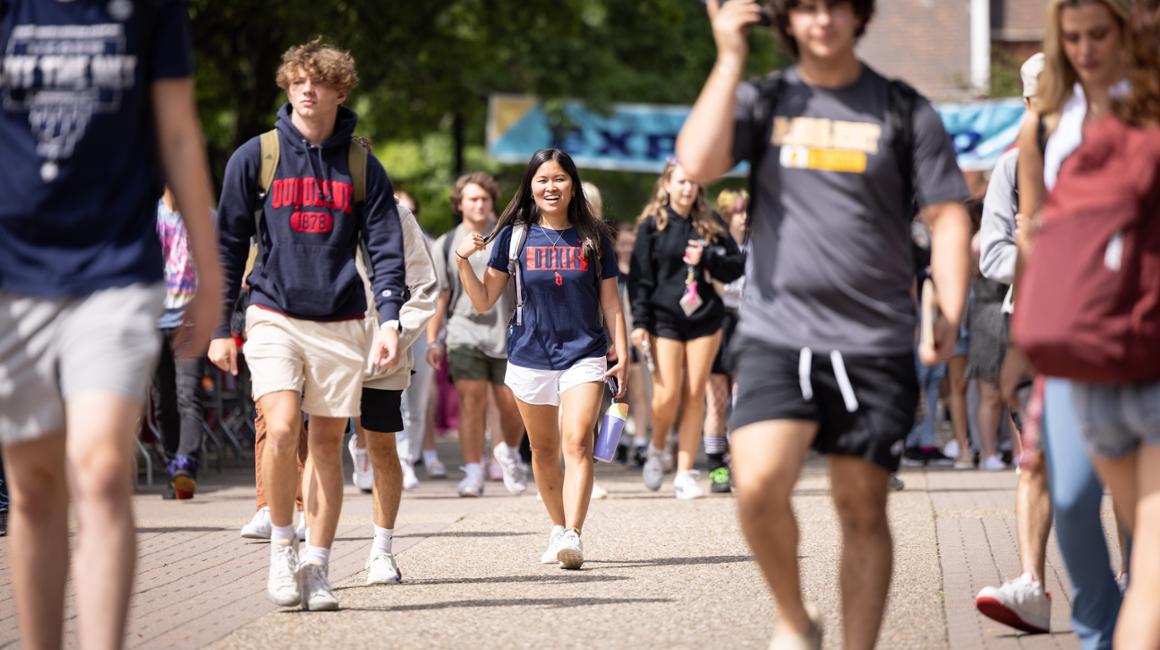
[216,104,406,338]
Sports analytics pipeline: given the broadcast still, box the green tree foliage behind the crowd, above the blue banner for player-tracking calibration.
[189,0,780,232]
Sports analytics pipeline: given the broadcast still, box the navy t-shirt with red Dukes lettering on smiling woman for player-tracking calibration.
[487,225,618,370]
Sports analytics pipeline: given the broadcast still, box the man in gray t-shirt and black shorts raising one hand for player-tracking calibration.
[676,0,969,649]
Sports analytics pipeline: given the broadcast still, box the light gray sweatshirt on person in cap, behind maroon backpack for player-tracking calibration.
[979,150,1018,284]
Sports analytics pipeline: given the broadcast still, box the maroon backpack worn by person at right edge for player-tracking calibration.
[1012,118,1160,383]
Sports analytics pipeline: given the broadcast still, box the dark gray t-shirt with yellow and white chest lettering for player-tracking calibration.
[733,65,969,354]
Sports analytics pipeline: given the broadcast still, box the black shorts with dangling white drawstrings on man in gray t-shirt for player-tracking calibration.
[730,337,919,472]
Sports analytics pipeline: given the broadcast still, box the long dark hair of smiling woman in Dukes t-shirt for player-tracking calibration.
[487,149,612,264]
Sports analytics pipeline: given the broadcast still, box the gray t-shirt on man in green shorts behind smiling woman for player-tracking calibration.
[432,224,515,359]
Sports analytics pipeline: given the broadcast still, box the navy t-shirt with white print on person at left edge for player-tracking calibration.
[0,0,193,297]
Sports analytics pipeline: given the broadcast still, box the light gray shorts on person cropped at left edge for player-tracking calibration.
[0,283,165,445]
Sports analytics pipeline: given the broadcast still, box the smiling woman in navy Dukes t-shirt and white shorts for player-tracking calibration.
[455,149,628,569]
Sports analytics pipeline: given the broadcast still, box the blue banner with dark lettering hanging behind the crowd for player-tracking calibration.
[487,95,1023,175]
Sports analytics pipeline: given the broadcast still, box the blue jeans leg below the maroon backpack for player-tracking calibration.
[1043,378,1121,650]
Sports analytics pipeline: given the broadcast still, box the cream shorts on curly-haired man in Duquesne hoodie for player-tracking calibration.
[242,305,370,418]
